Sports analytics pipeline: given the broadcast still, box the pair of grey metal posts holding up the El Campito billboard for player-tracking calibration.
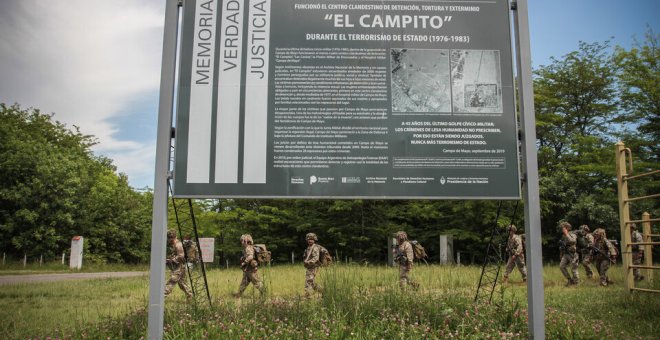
[147,0,545,339]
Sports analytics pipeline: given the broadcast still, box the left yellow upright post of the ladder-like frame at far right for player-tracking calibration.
[616,142,634,290]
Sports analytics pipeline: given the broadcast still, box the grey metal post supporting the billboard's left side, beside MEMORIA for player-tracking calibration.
[147,0,179,339]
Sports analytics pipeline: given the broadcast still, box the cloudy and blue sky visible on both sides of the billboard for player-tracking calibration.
[0,0,660,188]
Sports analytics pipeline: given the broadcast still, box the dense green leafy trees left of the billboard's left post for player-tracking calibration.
[0,104,150,262]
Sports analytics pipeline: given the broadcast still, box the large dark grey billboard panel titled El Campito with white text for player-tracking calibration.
[174,0,520,199]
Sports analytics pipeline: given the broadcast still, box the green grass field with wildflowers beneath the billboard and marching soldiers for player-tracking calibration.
[0,265,660,339]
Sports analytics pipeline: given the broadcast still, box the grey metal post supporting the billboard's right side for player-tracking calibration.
[513,0,545,339]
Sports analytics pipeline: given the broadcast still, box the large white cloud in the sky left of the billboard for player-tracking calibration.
[0,0,164,186]
